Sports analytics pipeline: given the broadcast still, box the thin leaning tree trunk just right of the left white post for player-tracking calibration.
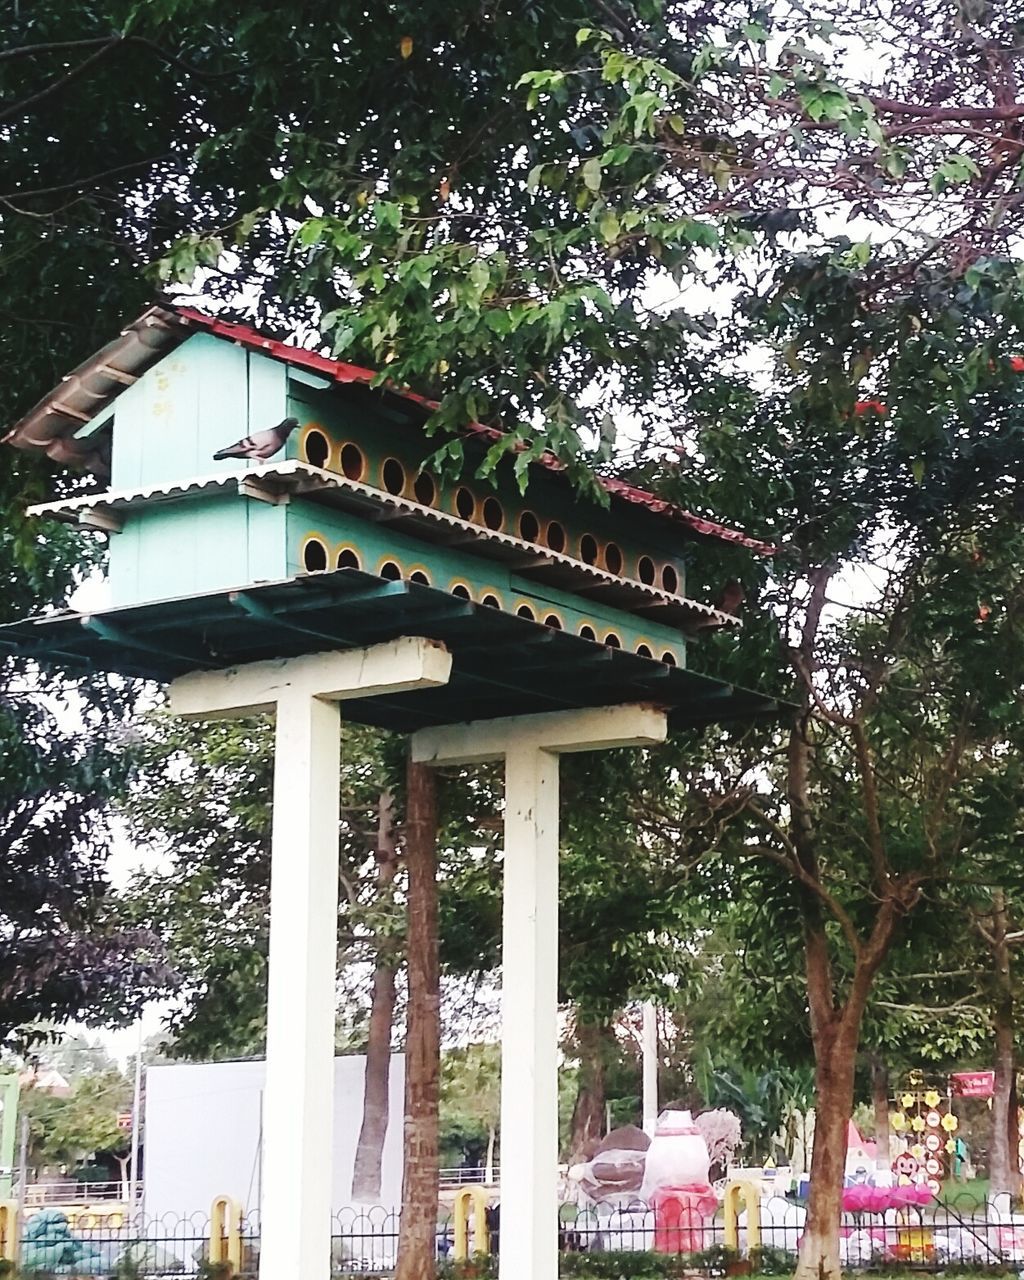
[352,791,397,1203]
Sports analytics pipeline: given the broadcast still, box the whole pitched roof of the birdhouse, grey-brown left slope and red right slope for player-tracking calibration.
[4,306,776,556]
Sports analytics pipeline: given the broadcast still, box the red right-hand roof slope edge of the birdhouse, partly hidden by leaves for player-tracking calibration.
[174,307,776,556]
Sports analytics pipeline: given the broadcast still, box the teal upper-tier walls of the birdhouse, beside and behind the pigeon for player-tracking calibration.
[99,334,687,595]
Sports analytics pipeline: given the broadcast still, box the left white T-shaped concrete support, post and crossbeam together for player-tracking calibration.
[169,637,452,1280]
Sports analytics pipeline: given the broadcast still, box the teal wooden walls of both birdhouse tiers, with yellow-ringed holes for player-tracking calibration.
[94,334,706,663]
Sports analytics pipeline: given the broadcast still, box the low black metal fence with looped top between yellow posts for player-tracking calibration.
[8,1197,1024,1280]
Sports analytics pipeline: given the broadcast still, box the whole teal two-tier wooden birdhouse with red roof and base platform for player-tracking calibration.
[0,306,771,728]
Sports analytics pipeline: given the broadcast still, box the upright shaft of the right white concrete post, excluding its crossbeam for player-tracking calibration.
[499,744,558,1280]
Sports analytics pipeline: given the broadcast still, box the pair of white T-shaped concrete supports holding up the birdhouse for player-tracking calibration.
[169,637,668,1280]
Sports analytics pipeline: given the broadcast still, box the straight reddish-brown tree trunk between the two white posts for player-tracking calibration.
[396,760,440,1280]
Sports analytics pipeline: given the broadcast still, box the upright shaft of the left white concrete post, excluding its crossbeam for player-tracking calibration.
[260,691,340,1280]
